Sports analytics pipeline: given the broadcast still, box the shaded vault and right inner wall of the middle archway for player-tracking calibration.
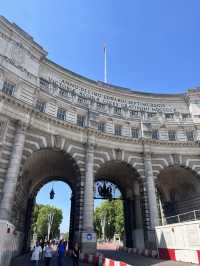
[95,160,144,247]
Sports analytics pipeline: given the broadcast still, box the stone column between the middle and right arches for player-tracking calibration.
[144,148,159,230]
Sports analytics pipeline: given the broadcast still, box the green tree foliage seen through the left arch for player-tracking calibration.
[32,204,63,239]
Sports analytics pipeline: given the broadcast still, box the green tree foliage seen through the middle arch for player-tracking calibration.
[94,200,124,240]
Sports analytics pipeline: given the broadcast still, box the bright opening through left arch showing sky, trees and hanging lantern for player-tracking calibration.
[31,181,72,246]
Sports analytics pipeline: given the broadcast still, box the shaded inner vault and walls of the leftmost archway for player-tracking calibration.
[13,149,80,251]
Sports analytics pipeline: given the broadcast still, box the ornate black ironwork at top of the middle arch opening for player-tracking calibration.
[95,180,121,200]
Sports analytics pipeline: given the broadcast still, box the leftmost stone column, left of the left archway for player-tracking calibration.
[0,122,26,221]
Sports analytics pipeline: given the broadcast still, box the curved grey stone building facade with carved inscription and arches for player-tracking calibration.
[0,17,200,260]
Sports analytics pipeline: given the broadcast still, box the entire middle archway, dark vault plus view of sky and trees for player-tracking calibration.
[95,160,144,249]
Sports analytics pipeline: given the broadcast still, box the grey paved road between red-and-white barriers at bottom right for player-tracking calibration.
[99,250,197,266]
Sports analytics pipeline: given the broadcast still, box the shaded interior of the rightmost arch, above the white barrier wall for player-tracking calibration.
[157,166,200,217]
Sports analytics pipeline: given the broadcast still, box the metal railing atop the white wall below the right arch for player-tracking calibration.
[161,210,200,225]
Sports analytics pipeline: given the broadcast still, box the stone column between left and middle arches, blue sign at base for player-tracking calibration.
[82,141,96,253]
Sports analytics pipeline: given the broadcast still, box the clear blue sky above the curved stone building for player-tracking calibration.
[0,0,200,92]
